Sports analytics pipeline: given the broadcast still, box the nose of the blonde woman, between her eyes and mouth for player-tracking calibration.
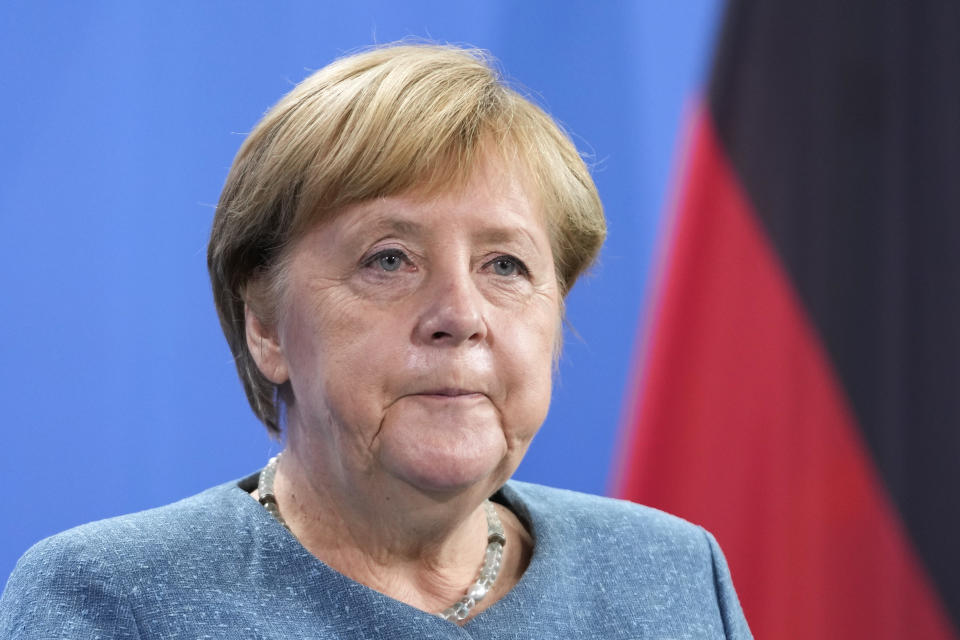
[416,272,487,346]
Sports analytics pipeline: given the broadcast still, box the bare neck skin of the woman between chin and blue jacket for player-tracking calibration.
[274,440,496,613]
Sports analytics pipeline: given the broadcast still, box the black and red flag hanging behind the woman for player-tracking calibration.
[615,0,960,640]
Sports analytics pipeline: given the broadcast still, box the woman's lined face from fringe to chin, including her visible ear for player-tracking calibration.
[248,156,560,510]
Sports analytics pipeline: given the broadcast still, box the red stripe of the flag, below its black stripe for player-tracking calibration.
[617,112,957,640]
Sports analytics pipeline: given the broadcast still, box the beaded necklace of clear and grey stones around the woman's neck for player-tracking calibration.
[257,454,507,621]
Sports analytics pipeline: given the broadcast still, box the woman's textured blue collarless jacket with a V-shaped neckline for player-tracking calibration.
[0,476,751,640]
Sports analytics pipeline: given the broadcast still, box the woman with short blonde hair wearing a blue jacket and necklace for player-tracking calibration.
[0,45,750,640]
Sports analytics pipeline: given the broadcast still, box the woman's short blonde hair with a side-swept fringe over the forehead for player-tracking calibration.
[207,43,606,435]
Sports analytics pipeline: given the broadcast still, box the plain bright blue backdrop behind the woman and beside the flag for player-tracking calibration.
[0,0,719,583]
